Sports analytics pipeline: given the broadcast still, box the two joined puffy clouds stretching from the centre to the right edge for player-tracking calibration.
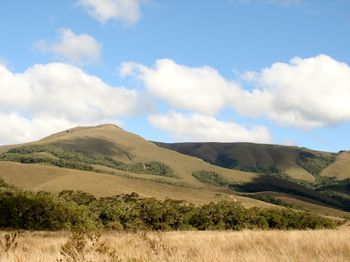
[121,55,350,129]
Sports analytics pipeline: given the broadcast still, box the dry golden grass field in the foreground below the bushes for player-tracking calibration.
[0,229,350,262]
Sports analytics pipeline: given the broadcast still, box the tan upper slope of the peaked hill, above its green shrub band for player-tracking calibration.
[26,125,257,185]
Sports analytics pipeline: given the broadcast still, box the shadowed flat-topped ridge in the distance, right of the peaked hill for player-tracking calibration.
[155,142,335,182]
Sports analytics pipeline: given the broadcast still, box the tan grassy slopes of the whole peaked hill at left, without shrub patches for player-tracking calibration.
[0,125,266,205]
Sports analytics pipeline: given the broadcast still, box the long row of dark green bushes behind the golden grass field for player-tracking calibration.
[0,179,336,231]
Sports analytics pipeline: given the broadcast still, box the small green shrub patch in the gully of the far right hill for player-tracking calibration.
[297,151,336,177]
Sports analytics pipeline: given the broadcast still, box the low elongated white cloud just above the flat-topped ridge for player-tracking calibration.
[149,112,271,143]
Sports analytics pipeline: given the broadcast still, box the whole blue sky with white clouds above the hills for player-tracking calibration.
[0,0,350,152]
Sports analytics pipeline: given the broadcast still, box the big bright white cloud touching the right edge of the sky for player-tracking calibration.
[242,55,350,128]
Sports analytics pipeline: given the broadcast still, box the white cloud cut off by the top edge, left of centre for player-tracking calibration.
[78,0,144,24]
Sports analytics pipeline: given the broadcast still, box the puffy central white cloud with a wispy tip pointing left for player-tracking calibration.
[121,59,241,115]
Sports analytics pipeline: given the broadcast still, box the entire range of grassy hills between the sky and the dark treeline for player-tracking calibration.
[0,125,350,216]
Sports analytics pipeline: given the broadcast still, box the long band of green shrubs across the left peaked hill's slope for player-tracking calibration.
[0,145,174,177]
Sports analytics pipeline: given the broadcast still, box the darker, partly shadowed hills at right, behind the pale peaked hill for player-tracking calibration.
[153,142,350,217]
